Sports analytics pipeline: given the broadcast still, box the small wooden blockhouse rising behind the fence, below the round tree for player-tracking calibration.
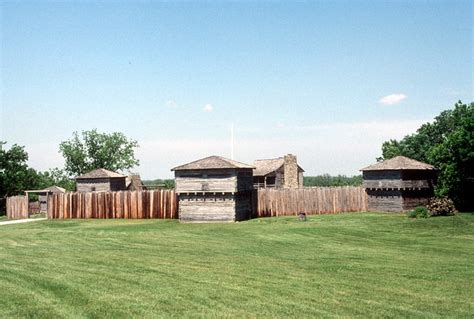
[76,168,127,192]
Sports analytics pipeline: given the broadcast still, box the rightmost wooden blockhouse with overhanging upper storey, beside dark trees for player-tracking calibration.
[361,156,436,212]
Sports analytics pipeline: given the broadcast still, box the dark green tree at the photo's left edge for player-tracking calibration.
[0,141,38,198]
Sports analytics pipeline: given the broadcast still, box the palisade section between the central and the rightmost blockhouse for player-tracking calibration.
[253,186,367,218]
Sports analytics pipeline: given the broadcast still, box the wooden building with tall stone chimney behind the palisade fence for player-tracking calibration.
[253,154,304,188]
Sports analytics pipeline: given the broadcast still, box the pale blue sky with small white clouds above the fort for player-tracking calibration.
[0,1,474,179]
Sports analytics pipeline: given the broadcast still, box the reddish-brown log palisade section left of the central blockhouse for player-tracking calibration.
[48,190,178,219]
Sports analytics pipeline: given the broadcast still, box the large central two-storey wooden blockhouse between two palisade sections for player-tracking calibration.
[172,156,253,222]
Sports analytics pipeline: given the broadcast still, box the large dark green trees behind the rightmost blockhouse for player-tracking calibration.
[378,101,474,210]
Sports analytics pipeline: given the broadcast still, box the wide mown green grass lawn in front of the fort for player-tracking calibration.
[0,213,474,318]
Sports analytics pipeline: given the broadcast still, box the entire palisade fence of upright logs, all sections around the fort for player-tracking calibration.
[7,186,367,219]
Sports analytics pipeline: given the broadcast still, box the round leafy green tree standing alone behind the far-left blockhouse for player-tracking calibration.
[59,129,139,176]
